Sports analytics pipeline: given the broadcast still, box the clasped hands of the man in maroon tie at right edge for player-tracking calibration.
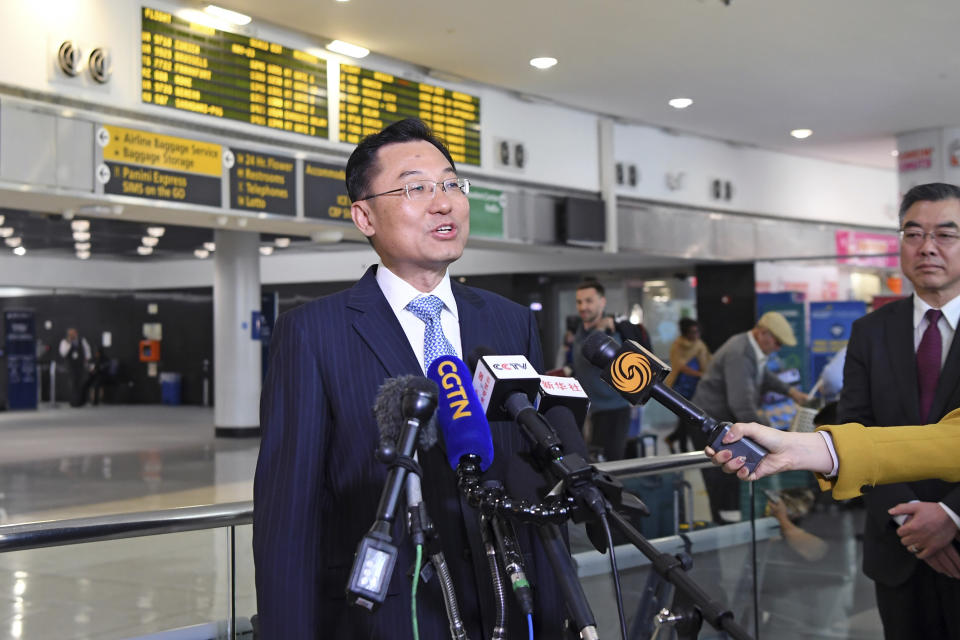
[887,502,960,578]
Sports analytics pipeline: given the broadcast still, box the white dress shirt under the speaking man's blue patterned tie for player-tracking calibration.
[377,264,463,374]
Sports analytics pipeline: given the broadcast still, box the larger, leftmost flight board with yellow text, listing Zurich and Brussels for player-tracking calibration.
[140,7,329,138]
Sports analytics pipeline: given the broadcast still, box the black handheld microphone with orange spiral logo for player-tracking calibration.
[583,332,767,473]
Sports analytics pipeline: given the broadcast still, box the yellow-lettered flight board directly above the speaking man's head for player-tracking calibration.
[340,64,480,166]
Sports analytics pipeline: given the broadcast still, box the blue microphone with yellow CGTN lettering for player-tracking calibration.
[427,356,493,471]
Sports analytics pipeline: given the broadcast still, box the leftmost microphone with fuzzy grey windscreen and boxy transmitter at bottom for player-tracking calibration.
[347,376,438,611]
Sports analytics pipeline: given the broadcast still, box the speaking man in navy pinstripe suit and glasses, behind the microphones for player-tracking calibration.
[253,119,565,640]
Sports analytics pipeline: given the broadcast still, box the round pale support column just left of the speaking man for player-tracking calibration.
[213,229,261,437]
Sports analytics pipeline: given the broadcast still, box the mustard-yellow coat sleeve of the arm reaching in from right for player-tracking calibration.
[817,409,960,500]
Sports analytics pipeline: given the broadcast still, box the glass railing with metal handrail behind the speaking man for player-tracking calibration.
[0,452,840,640]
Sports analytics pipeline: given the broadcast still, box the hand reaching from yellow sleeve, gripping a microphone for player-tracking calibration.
[704,422,833,480]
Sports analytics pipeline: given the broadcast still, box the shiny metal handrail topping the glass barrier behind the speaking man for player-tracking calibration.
[0,451,711,553]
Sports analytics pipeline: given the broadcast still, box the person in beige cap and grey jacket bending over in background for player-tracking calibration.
[691,311,806,524]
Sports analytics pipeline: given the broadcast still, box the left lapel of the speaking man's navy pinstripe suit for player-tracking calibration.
[347,266,420,377]
